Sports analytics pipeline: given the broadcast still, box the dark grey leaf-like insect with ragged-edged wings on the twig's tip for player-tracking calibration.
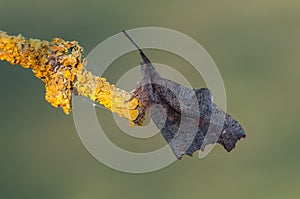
[133,43,246,159]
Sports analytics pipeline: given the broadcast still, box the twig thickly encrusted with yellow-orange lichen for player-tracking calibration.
[0,32,144,125]
